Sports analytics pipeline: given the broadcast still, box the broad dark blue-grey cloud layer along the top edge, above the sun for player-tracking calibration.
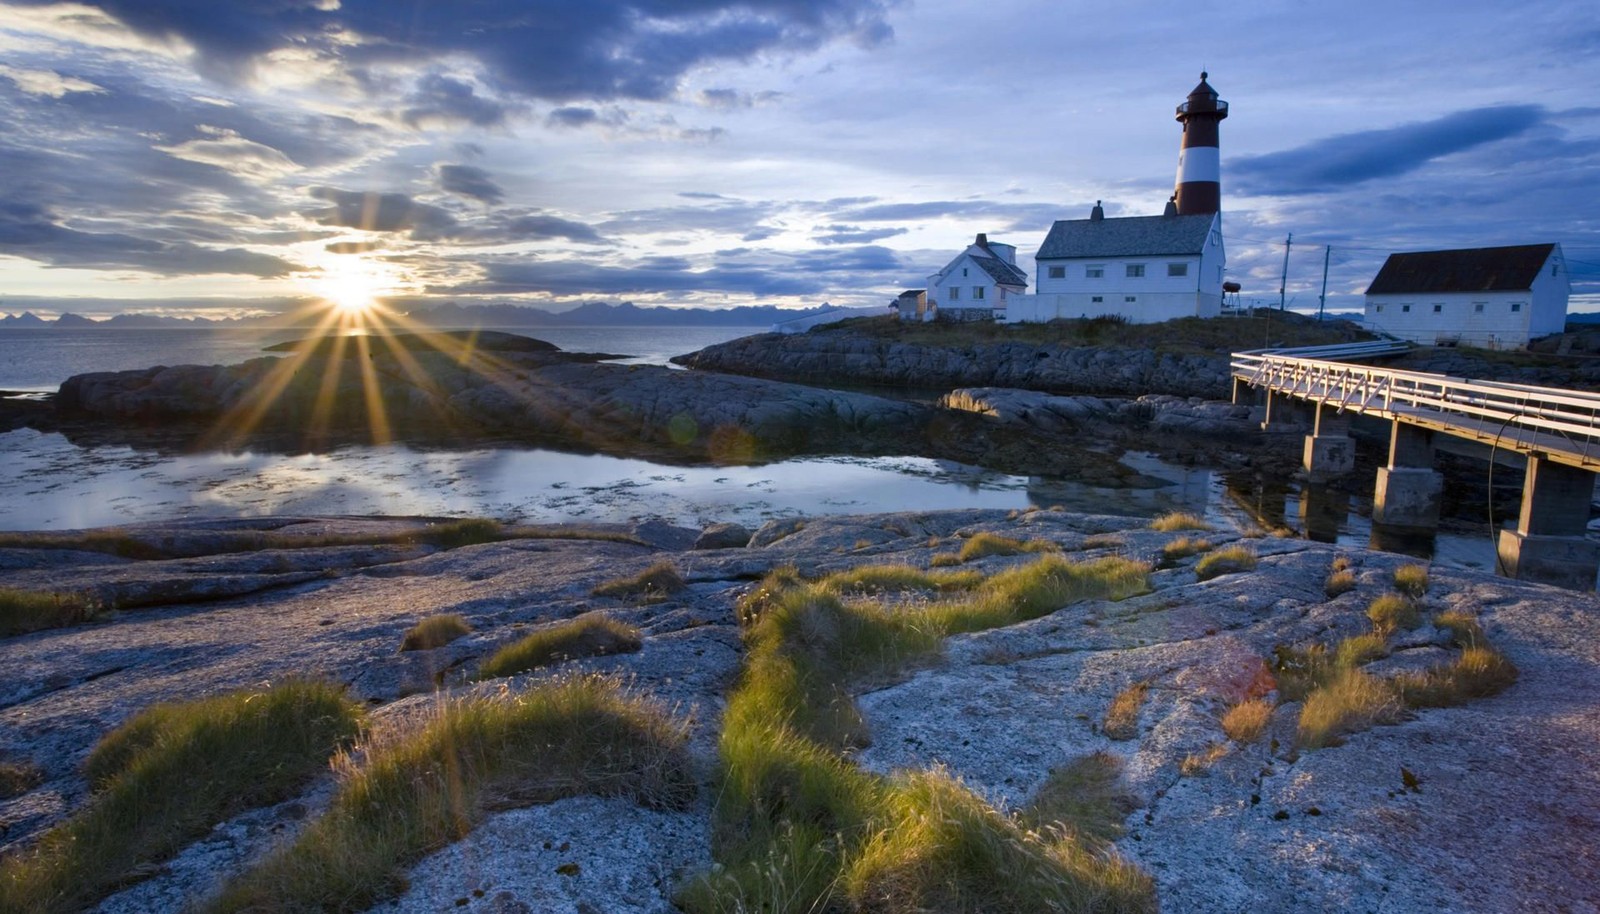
[18,0,890,102]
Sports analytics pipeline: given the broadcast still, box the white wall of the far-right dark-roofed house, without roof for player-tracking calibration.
[1365,245,1571,349]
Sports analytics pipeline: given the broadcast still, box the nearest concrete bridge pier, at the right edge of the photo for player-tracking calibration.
[1496,455,1600,591]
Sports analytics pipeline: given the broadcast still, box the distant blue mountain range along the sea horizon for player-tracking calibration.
[0,301,857,330]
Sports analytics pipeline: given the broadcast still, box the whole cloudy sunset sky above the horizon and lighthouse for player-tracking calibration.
[0,0,1600,317]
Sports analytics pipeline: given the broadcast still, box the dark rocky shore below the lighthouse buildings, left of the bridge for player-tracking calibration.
[675,331,1229,399]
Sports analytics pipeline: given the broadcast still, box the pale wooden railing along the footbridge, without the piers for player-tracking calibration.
[1232,351,1600,466]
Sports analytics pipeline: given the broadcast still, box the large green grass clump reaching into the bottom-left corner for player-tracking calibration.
[0,682,363,914]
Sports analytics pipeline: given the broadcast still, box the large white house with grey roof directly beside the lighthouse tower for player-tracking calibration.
[1006,203,1227,323]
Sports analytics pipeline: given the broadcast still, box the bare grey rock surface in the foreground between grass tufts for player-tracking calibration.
[0,511,1600,912]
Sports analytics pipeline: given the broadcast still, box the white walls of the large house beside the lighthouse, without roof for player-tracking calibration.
[1006,216,1227,323]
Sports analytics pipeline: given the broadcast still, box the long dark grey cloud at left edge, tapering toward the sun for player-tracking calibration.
[0,202,301,279]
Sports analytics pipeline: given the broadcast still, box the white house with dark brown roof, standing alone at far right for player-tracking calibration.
[1365,245,1571,349]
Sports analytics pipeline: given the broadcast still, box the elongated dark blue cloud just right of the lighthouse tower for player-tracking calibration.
[1227,104,1546,195]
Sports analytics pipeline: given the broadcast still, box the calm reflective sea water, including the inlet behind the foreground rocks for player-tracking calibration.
[0,327,1493,567]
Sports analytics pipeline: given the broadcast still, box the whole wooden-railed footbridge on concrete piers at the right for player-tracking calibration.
[1232,343,1600,589]
